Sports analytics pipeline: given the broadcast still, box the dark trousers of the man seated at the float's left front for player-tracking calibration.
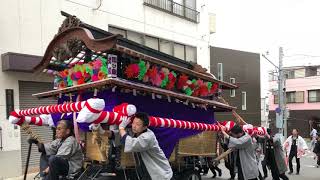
[40,154,69,180]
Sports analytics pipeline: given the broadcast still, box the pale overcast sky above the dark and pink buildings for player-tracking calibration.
[209,0,320,96]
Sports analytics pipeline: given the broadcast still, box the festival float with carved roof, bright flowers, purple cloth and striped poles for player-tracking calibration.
[9,13,266,179]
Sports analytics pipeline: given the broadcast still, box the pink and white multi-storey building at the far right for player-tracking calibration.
[269,66,320,137]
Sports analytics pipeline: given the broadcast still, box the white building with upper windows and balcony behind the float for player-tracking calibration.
[0,0,214,179]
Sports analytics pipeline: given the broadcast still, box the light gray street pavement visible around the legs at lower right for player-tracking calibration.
[202,151,320,180]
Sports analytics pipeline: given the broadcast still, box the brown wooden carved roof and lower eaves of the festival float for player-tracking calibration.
[34,13,237,111]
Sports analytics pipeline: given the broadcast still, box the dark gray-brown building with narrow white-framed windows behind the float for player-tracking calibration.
[210,47,261,126]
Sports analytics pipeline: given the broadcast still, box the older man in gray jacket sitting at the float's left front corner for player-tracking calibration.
[29,120,83,180]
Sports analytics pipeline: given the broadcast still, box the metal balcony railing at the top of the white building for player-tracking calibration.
[144,0,199,23]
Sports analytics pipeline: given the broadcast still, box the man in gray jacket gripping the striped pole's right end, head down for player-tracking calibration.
[222,125,259,180]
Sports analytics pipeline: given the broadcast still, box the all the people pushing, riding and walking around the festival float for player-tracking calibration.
[29,113,320,180]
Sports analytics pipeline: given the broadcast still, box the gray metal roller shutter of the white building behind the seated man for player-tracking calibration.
[19,81,57,173]
